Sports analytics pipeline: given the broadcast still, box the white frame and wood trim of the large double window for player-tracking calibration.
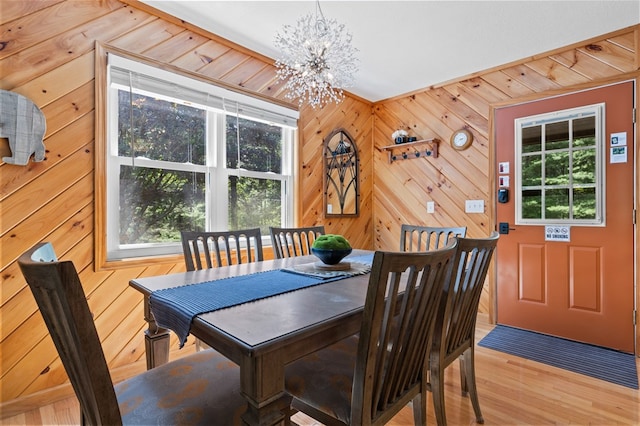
[94,46,299,270]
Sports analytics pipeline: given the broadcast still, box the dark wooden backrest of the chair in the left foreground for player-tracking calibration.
[18,243,122,425]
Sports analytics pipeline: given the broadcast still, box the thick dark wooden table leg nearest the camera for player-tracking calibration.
[240,352,291,426]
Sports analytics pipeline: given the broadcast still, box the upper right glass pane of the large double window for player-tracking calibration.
[227,115,282,173]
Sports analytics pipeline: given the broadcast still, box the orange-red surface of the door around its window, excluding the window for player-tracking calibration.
[495,82,634,353]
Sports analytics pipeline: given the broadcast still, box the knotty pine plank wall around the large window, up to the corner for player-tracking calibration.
[0,0,373,408]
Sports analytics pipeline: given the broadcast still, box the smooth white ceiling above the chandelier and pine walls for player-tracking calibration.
[143,0,640,102]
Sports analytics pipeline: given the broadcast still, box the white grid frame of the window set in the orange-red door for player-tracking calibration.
[514,103,607,227]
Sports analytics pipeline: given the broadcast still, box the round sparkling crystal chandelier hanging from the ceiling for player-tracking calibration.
[275,0,358,108]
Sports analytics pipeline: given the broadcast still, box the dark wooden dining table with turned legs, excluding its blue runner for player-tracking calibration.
[130,250,373,425]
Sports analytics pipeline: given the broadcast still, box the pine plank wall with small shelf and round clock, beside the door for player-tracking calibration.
[373,26,640,320]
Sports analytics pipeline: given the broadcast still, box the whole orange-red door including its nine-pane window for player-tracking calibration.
[495,81,634,353]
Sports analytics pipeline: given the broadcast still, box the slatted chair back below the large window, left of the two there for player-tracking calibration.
[180,228,264,271]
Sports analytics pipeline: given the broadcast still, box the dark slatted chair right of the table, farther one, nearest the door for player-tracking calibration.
[429,232,499,426]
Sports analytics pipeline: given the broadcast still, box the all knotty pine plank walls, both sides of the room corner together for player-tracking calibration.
[0,0,639,417]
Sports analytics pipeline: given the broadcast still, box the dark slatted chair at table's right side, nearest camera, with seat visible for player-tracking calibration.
[285,242,455,425]
